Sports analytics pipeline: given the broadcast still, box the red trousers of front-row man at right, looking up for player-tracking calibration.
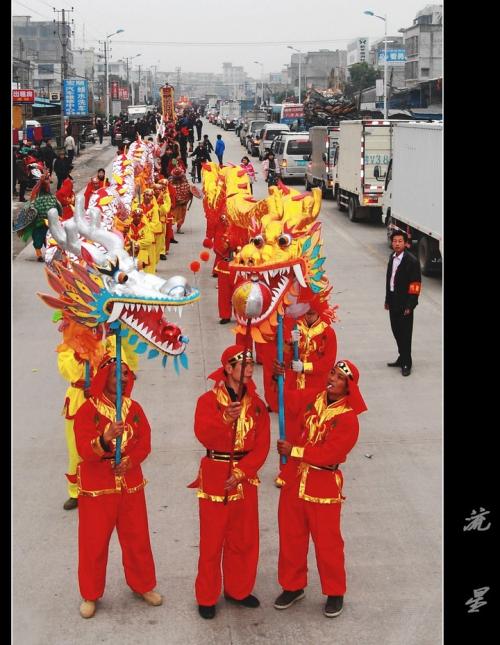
[278,478,346,596]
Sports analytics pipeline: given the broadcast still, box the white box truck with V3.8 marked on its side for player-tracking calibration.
[335,119,392,222]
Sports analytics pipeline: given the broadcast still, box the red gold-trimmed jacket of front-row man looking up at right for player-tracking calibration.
[280,389,359,504]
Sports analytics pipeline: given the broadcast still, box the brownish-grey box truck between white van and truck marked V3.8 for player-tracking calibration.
[305,125,340,197]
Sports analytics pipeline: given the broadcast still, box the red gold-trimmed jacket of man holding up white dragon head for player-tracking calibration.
[74,397,151,497]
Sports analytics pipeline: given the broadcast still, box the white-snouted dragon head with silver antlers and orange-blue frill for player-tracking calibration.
[38,196,200,358]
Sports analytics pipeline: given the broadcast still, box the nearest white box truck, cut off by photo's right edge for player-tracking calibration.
[383,121,443,275]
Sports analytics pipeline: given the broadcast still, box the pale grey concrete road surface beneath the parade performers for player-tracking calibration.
[13,122,442,645]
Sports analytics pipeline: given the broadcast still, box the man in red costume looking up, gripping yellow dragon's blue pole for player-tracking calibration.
[274,360,367,617]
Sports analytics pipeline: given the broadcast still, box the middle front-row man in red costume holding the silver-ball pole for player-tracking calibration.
[189,345,270,618]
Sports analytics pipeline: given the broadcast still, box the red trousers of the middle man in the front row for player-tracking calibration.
[195,483,259,606]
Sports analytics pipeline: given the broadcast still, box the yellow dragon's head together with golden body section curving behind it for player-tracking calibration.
[203,163,332,343]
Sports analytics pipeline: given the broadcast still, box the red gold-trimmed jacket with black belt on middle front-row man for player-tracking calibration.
[189,382,270,502]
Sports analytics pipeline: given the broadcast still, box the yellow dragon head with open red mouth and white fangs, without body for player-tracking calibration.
[230,184,331,342]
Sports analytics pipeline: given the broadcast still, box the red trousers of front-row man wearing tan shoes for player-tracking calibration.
[78,490,156,600]
